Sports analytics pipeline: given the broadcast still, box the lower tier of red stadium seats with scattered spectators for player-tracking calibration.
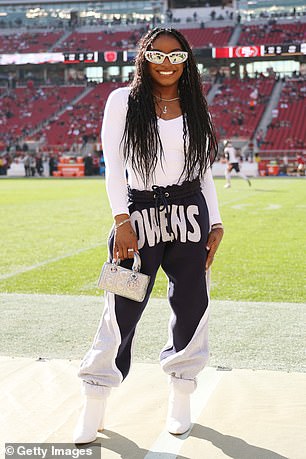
[0,74,306,162]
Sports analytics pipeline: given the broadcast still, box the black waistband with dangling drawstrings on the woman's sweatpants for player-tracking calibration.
[128,178,201,239]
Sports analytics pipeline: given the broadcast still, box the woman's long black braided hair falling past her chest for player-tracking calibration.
[122,28,218,184]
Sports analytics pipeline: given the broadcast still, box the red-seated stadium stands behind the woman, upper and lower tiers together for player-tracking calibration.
[0,0,306,176]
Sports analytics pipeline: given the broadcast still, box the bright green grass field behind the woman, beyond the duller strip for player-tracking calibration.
[0,178,306,303]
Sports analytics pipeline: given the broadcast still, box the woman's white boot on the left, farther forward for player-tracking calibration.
[73,395,106,444]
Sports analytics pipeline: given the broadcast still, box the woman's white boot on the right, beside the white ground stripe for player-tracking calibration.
[167,377,196,435]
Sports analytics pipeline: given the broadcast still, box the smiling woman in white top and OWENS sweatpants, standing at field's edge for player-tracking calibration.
[74,28,223,443]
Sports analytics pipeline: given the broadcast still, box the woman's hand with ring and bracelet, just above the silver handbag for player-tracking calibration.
[113,216,138,261]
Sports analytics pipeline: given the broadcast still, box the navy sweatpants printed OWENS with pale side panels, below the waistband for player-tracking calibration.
[79,187,209,393]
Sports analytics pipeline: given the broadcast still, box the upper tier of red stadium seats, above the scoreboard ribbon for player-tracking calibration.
[0,18,306,53]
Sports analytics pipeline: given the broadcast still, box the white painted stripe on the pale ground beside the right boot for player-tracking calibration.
[144,367,223,459]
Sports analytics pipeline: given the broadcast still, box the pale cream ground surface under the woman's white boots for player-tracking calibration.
[0,357,306,459]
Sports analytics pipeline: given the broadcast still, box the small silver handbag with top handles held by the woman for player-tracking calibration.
[98,252,150,302]
